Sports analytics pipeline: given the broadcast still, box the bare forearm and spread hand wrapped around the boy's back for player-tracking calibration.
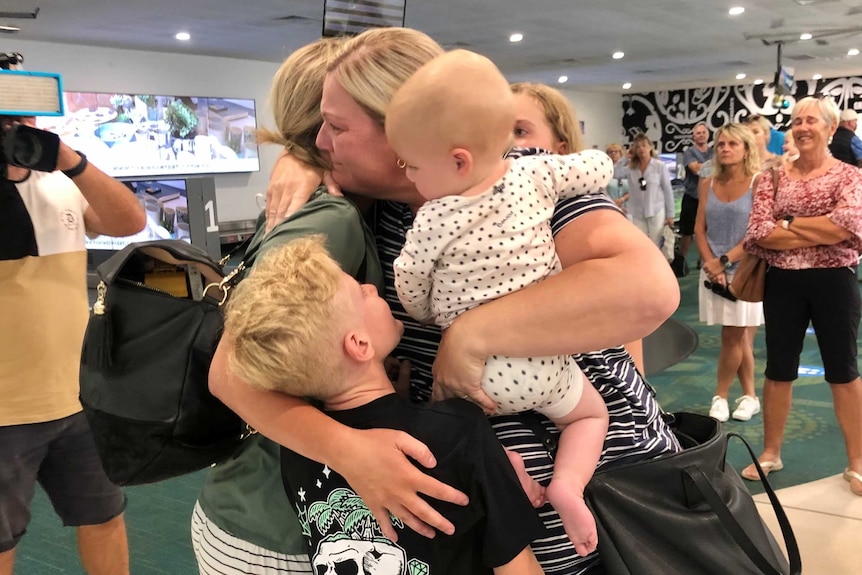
[209,335,468,541]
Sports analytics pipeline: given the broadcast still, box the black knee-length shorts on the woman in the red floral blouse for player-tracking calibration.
[763,267,862,383]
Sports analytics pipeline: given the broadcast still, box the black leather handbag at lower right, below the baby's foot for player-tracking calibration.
[584,413,802,575]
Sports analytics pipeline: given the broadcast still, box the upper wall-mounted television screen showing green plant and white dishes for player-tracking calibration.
[36,92,260,178]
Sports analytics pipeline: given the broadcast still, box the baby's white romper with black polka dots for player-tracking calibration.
[394,150,613,419]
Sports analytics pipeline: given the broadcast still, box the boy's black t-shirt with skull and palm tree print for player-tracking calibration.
[281,393,544,575]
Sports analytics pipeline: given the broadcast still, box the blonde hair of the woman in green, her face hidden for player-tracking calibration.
[257,38,345,168]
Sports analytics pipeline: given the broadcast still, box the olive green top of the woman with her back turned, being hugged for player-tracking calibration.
[198,188,383,555]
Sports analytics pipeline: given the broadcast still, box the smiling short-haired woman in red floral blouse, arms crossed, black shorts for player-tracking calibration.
[742,97,862,496]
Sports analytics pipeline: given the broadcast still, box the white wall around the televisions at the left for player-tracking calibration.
[3,39,279,222]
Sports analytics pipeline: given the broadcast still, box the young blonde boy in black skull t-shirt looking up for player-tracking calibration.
[225,236,544,575]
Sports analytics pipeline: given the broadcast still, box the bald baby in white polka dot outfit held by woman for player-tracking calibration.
[386,50,613,556]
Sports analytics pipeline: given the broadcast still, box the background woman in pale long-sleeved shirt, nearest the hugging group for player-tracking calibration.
[628,134,676,246]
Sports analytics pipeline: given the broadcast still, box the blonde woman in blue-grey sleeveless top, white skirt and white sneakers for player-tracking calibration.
[694,124,766,421]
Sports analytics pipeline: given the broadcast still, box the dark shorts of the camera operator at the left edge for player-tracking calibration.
[0,412,126,553]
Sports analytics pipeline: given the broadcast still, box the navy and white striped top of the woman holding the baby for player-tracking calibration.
[374,182,679,575]
